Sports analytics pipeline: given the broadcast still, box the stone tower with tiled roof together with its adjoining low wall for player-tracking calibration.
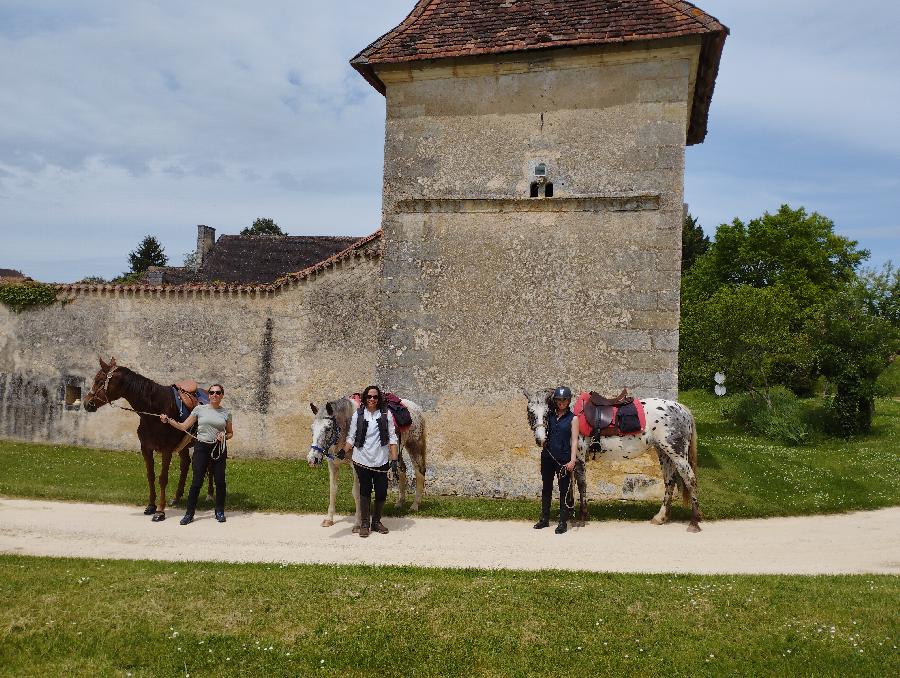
[0,0,727,498]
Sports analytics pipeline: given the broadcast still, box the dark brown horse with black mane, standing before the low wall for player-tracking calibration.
[83,358,206,522]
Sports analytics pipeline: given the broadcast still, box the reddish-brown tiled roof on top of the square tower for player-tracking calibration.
[350,0,728,144]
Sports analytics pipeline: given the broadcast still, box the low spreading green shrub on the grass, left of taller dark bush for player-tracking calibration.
[722,386,810,445]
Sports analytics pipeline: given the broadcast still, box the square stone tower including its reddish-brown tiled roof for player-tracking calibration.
[351,0,728,493]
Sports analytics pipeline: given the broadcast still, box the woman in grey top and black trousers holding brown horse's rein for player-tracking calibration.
[159,384,234,525]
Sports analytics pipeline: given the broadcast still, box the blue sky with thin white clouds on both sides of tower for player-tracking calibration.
[0,0,900,282]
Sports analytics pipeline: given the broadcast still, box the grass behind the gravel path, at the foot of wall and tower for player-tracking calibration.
[0,392,900,520]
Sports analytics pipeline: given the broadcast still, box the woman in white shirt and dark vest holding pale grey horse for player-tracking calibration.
[344,386,398,537]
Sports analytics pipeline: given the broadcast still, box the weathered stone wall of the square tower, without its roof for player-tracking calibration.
[377,39,699,497]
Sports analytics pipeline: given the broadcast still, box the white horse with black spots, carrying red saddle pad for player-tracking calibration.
[525,389,703,532]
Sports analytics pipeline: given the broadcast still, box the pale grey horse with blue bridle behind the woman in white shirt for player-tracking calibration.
[306,398,425,528]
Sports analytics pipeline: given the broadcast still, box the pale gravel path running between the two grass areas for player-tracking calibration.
[0,498,900,574]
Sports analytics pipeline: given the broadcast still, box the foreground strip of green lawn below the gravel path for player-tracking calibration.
[0,556,900,676]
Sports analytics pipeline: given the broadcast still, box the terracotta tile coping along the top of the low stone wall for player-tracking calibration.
[56,229,382,295]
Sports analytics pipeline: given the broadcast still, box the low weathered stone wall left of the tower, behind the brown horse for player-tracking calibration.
[0,242,380,458]
